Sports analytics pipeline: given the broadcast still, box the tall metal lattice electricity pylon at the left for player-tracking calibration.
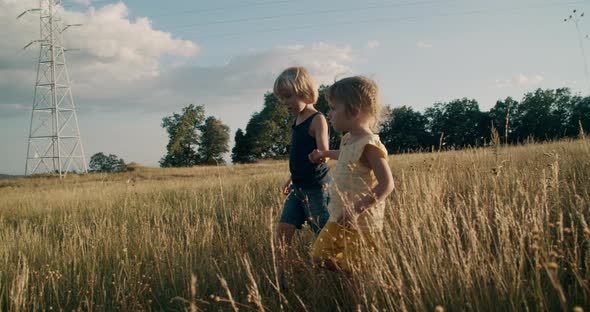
[18,0,88,177]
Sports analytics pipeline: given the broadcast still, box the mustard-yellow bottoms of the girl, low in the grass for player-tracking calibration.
[311,222,377,272]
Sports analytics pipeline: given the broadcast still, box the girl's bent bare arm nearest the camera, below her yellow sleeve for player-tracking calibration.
[354,145,394,213]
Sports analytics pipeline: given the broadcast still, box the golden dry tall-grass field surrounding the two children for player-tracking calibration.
[0,140,590,311]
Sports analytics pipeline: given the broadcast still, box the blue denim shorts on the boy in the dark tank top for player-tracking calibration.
[279,184,330,234]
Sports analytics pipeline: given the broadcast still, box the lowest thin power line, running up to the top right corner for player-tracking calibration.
[184,1,584,39]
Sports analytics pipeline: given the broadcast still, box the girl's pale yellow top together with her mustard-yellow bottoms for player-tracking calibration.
[312,134,387,271]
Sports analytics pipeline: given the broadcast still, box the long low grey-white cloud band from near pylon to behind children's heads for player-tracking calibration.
[56,43,355,108]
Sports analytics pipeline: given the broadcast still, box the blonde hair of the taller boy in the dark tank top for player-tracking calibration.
[273,67,318,104]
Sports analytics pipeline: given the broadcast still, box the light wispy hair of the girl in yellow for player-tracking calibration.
[326,76,383,131]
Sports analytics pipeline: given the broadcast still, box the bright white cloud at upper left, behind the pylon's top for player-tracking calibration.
[0,0,199,109]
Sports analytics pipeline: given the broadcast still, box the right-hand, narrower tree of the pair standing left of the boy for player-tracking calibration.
[198,116,229,165]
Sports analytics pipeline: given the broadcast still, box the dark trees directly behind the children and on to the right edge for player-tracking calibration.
[232,86,590,163]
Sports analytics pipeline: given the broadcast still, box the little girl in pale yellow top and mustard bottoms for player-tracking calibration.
[309,76,394,272]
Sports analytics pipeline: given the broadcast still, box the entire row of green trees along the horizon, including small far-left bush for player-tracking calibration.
[90,86,590,172]
